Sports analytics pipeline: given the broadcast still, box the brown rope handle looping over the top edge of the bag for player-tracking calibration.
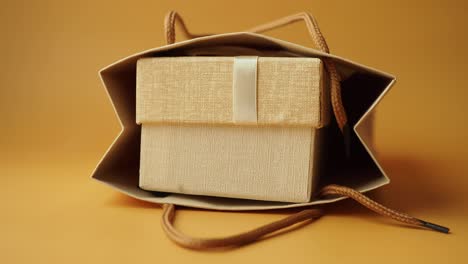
[164,11,351,138]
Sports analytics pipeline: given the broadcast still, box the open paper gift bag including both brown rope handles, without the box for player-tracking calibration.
[92,12,448,249]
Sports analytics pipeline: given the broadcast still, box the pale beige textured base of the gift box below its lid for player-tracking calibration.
[140,124,317,202]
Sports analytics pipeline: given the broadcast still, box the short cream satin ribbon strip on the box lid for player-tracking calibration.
[232,56,258,123]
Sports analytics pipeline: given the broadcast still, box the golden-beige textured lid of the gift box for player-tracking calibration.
[136,56,330,127]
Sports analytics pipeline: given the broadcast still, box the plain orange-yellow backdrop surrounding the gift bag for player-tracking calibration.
[0,0,468,263]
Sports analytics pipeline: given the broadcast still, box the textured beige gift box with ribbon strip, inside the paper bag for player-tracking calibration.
[136,56,330,202]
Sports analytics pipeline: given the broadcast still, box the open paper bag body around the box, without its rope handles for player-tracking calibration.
[92,20,395,211]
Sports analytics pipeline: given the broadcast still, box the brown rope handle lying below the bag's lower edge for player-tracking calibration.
[162,185,449,250]
